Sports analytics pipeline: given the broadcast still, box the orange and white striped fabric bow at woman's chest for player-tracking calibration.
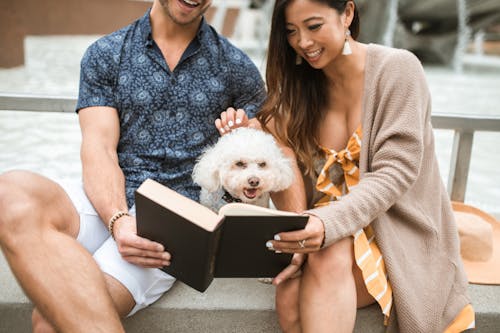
[316,127,361,206]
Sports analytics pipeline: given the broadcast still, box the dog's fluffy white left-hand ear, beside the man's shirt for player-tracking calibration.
[192,147,221,192]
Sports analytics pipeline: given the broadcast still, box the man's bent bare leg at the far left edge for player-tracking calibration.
[0,172,123,332]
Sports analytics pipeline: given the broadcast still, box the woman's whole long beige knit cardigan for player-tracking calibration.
[309,44,470,333]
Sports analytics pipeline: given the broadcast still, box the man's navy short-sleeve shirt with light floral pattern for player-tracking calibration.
[77,11,265,206]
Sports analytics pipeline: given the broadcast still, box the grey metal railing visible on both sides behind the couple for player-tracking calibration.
[0,93,500,202]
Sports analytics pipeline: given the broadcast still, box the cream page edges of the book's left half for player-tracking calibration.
[137,179,221,231]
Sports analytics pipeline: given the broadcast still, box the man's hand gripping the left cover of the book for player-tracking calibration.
[113,216,170,268]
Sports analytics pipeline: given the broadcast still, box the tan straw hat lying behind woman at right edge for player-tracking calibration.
[452,202,500,284]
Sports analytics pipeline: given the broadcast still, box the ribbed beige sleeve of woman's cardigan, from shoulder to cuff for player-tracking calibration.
[307,50,430,246]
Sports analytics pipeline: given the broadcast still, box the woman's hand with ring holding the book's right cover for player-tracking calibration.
[266,215,325,253]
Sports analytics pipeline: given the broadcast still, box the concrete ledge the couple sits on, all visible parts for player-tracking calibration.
[0,255,500,333]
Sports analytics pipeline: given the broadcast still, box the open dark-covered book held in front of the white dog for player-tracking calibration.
[135,179,307,292]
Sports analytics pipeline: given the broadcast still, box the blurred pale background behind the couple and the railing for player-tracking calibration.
[0,0,500,215]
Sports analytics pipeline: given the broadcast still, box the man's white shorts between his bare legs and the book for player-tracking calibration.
[59,182,175,316]
